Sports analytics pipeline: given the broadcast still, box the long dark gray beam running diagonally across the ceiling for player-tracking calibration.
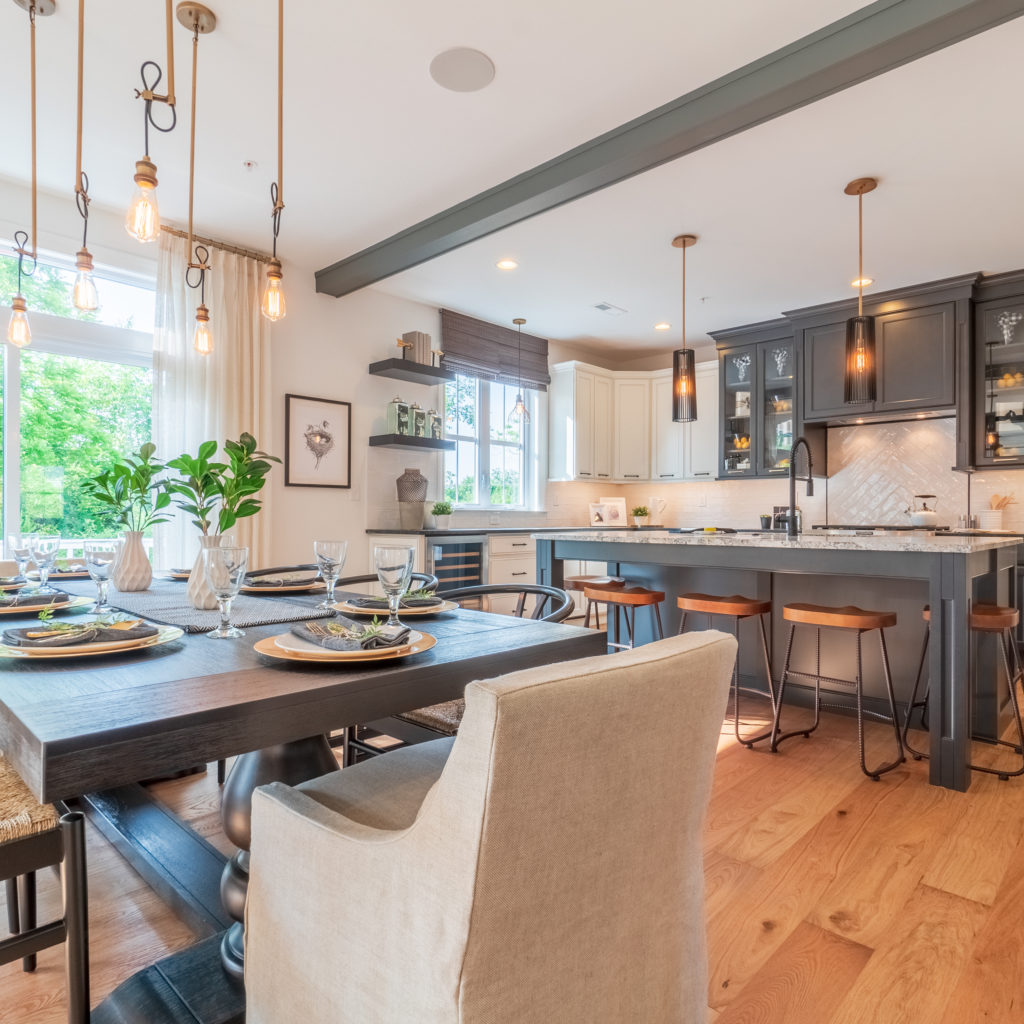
[316,0,1024,296]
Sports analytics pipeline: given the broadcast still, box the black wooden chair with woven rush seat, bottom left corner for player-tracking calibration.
[0,755,89,1024]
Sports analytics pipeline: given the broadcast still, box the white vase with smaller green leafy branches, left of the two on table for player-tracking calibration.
[86,441,171,591]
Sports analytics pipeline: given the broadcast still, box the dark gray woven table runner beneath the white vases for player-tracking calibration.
[60,580,335,633]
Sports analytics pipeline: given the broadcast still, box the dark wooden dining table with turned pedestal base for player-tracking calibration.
[0,588,607,1024]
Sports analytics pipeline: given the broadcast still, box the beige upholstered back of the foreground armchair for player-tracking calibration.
[432,631,736,1024]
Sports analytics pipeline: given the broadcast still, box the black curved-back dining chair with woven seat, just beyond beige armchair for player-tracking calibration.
[344,583,575,765]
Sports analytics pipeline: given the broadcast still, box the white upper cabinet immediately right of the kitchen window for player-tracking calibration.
[548,362,612,480]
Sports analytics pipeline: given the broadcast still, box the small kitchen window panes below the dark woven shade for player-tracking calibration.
[444,375,536,508]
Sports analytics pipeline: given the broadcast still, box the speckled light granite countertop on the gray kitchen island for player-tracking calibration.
[532,529,1020,555]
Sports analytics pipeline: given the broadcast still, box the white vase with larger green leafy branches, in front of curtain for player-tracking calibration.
[165,433,281,608]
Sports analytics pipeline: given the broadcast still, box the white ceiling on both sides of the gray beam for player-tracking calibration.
[0,0,1011,357]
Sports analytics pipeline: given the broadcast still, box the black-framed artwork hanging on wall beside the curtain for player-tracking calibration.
[285,394,352,487]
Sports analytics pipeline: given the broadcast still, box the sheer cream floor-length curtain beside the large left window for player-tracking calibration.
[153,231,272,567]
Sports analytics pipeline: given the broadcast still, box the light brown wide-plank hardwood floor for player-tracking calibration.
[6,706,1024,1024]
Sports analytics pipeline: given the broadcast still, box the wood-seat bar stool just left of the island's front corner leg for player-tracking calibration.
[771,604,906,781]
